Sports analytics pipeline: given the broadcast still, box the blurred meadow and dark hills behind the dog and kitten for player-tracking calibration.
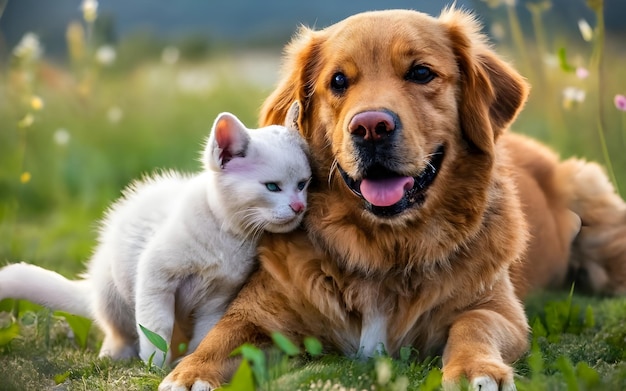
[0,0,626,276]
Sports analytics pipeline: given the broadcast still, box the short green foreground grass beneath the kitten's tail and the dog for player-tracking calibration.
[0,292,626,391]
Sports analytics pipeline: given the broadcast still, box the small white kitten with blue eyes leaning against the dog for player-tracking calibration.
[0,102,311,365]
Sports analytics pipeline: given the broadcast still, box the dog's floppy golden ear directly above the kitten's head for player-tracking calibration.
[259,27,321,130]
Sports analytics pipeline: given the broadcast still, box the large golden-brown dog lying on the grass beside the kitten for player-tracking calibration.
[159,9,626,391]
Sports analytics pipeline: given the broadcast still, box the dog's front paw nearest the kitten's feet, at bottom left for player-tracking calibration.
[159,357,221,391]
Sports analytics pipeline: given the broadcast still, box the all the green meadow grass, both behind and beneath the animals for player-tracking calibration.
[0,3,626,390]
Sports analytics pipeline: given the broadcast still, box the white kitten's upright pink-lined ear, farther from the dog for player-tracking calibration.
[204,113,250,170]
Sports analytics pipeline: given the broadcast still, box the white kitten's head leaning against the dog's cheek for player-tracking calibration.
[203,111,311,235]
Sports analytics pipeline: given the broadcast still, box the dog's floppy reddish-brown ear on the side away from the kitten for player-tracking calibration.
[439,9,528,153]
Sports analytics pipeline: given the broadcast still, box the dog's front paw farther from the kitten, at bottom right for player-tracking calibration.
[443,362,516,391]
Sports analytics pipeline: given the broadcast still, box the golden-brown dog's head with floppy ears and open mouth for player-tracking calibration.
[261,9,527,264]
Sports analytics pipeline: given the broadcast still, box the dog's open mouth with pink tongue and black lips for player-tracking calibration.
[337,145,445,217]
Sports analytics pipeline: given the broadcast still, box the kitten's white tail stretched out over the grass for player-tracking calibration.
[0,263,93,319]
